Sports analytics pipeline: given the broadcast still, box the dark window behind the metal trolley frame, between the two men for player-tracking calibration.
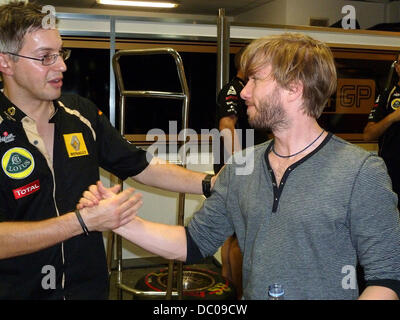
[63,48,222,134]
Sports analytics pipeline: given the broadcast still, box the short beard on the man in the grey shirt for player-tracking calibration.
[248,90,288,131]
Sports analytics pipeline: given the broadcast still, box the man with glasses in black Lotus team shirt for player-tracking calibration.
[0,2,216,299]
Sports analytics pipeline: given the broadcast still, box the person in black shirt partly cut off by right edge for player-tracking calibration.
[363,54,400,209]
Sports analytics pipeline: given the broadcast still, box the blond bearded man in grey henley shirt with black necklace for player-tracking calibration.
[82,34,400,299]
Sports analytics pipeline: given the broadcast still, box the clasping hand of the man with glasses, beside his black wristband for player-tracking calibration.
[78,187,143,231]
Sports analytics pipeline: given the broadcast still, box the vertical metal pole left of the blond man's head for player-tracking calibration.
[216,9,230,96]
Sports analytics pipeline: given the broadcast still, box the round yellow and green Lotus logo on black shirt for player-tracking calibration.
[1,147,35,179]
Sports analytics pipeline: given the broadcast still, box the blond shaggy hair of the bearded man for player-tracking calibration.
[241,33,337,119]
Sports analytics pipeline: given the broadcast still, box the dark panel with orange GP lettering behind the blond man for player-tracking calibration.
[318,49,397,140]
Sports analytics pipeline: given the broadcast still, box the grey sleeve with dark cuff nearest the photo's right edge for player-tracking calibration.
[349,155,400,285]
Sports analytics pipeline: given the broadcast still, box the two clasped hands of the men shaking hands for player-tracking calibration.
[75,181,143,234]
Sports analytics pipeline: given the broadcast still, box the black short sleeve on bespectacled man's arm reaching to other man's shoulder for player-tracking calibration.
[90,99,152,180]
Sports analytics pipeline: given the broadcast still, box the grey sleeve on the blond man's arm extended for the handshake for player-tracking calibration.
[187,166,234,257]
